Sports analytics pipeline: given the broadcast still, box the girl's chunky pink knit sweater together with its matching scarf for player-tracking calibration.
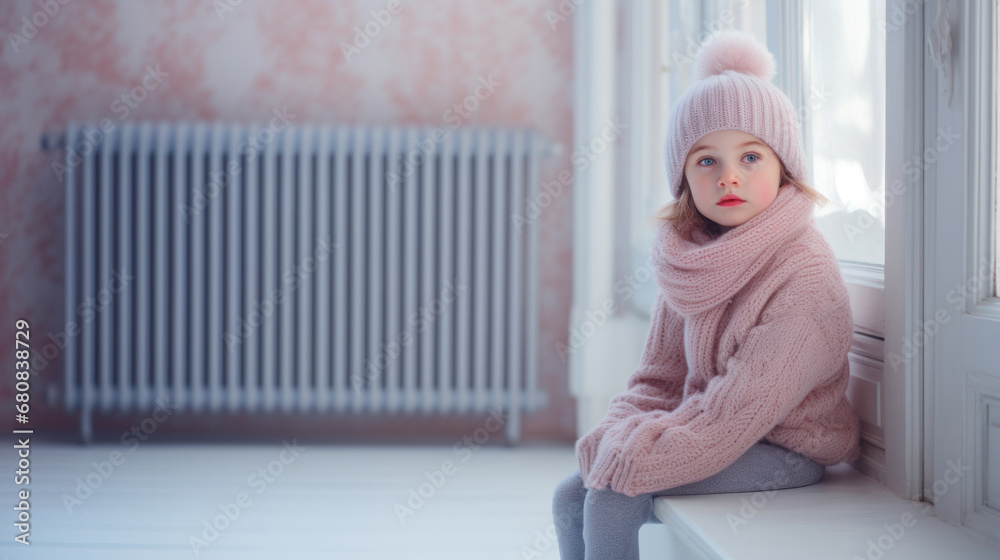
[576,186,859,496]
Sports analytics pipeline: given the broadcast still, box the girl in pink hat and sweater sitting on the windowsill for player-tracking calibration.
[553,32,859,560]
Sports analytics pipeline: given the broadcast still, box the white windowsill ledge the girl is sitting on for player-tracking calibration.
[653,463,1000,560]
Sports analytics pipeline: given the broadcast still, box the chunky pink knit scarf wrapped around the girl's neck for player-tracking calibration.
[651,185,813,317]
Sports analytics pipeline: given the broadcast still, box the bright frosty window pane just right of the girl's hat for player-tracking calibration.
[798,0,886,266]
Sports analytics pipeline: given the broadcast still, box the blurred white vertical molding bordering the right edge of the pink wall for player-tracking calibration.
[568,2,638,435]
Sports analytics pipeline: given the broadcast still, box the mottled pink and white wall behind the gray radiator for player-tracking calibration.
[0,0,575,441]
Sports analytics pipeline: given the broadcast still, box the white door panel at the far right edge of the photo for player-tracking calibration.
[918,2,1000,543]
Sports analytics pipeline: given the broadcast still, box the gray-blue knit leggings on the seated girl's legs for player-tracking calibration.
[552,440,825,560]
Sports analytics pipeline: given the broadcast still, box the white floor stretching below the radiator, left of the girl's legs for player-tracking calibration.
[0,441,576,560]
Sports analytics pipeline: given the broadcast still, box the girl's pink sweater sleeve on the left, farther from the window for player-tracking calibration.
[576,292,687,480]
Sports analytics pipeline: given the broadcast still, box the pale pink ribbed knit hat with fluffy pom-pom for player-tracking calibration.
[665,31,806,198]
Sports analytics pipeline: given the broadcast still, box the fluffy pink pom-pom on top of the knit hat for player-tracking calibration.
[694,31,776,80]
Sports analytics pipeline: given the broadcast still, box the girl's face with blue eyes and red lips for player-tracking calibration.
[684,130,781,227]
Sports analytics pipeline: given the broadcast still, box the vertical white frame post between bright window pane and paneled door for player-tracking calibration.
[882,0,928,500]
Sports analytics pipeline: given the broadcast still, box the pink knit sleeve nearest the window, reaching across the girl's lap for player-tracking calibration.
[588,315,849,496]
